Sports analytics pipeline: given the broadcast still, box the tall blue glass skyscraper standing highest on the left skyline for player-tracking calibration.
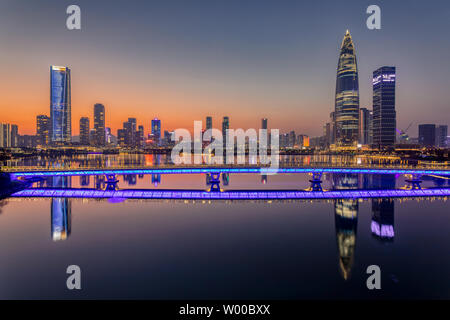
[50,66,72,145]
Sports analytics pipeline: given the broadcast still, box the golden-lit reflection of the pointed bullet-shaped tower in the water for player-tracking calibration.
[333,174,358,280]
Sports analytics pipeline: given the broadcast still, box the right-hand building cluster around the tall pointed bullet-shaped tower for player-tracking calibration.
[311,30,447,150]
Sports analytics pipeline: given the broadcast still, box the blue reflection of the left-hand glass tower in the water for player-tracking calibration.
[51,177,72,241]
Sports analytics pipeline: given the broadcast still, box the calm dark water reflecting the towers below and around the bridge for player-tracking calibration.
[0,155,450,299]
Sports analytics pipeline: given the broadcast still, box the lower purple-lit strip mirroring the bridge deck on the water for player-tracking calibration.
[12,188,450,200]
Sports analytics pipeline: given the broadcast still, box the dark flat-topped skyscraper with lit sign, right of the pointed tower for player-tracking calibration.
[372,67,396,147]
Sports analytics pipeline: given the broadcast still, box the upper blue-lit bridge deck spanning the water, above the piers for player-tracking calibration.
[9,166,450,179]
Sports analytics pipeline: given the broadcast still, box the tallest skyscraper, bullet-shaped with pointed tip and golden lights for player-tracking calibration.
[334,30,359,146]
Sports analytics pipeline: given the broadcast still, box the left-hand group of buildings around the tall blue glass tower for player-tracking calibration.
[0,66,170,148]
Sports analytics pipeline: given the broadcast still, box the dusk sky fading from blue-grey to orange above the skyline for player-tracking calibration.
[0,0,450,136]
